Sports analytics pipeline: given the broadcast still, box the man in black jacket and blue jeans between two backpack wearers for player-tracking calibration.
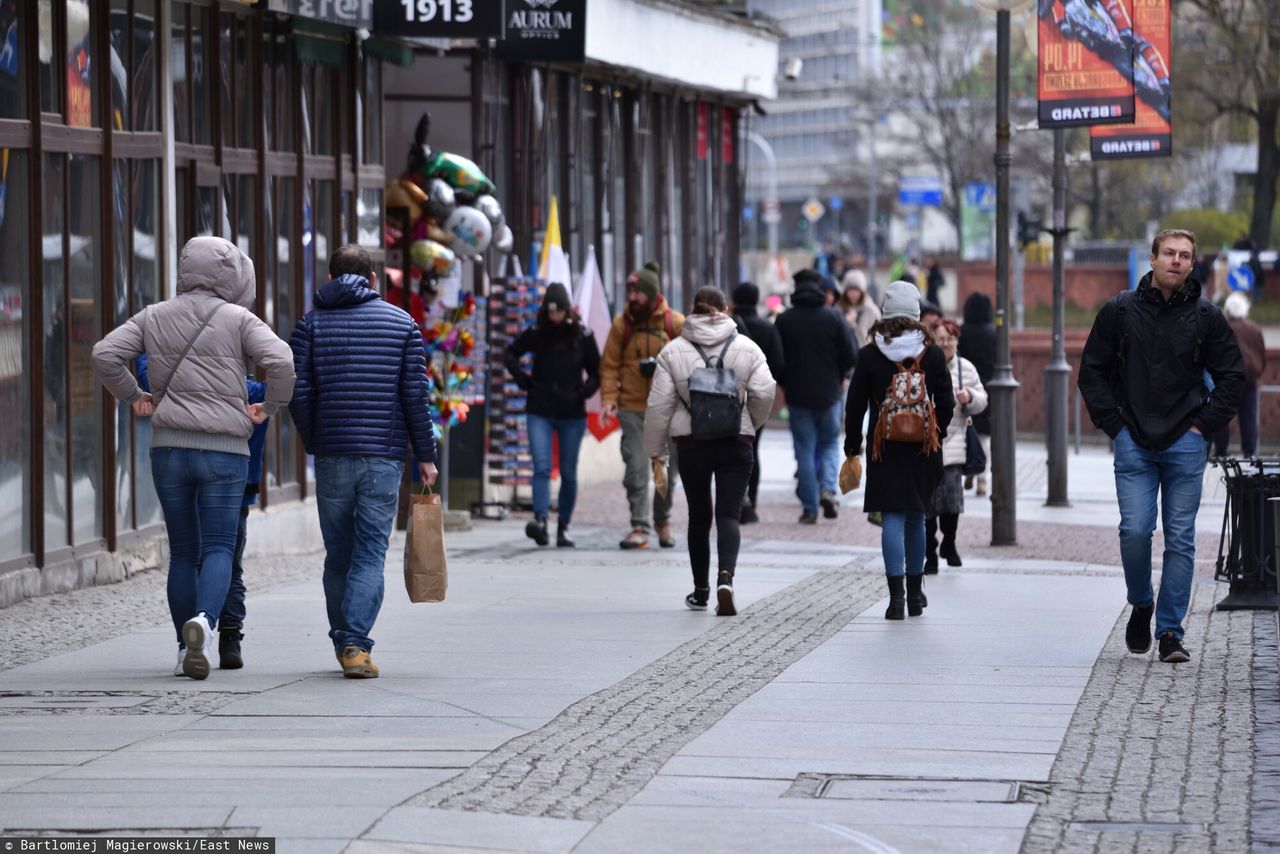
[777,270,858,525]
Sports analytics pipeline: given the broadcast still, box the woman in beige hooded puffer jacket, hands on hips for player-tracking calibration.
[92,237,294,679]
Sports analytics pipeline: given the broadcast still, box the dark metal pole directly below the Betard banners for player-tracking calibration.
[1044,128,1071,507]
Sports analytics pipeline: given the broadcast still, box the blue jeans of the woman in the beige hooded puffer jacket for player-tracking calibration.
[151,448,248,644]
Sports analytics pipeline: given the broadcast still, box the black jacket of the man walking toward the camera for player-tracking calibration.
[1079,273,1244,451]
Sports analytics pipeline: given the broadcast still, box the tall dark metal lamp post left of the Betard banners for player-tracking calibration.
[987,9,1018,545]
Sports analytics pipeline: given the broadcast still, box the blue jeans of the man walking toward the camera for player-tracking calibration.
[1115,428,1208,639]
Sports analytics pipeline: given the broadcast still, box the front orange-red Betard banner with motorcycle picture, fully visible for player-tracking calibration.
[1037,0,1134,128]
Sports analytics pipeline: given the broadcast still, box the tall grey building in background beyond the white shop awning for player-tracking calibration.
[742,0,882,248]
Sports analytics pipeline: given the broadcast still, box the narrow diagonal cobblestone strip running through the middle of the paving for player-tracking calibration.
[410,560,883,819]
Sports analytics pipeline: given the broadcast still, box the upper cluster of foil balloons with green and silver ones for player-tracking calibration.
[387,113,515,286]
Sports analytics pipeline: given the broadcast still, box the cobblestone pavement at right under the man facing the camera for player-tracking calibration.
[1023,584,1274,854]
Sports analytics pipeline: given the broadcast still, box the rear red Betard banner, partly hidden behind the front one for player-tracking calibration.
[1089,0,1174,160]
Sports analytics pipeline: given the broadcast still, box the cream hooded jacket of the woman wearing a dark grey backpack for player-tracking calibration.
[644,314,777,458]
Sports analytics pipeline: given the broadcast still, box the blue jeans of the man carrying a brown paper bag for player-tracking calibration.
[316,457,404,652]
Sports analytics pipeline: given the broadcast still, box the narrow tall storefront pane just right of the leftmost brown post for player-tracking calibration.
[37,154,69,549]
